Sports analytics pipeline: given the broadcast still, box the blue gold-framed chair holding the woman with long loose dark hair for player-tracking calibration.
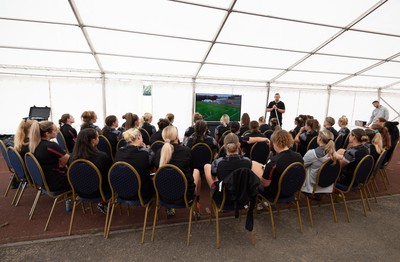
[67,159,110,236]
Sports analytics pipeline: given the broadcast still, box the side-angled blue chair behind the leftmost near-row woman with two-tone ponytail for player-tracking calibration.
[25,153,71,231]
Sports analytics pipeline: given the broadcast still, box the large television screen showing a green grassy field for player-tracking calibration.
[195,94,242,121]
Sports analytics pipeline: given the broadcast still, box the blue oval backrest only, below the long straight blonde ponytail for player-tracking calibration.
[153,164,189,207]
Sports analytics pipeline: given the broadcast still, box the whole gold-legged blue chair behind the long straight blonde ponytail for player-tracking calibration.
[151,164,197,245]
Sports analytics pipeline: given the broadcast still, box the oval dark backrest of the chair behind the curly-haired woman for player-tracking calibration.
[274,162,306,203]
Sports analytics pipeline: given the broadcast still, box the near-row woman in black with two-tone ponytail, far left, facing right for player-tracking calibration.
[29,121,71,191]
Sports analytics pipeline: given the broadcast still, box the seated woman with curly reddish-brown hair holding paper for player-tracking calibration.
[252,130,304,199]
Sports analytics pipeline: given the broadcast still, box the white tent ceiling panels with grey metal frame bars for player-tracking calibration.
[0,0,400,90]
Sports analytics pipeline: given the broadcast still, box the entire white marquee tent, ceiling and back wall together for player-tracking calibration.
[0,0,400,136]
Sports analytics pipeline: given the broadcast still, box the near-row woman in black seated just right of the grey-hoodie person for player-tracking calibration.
[337,128,369,186]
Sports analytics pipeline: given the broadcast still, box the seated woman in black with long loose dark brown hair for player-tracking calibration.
[70,128,112,214]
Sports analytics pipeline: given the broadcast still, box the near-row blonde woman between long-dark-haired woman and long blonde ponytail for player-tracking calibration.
[115,128,154,199]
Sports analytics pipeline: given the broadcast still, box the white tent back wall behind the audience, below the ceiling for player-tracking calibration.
[0,73,400,135]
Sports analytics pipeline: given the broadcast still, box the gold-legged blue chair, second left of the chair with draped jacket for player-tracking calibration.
[106,162,154,243]
